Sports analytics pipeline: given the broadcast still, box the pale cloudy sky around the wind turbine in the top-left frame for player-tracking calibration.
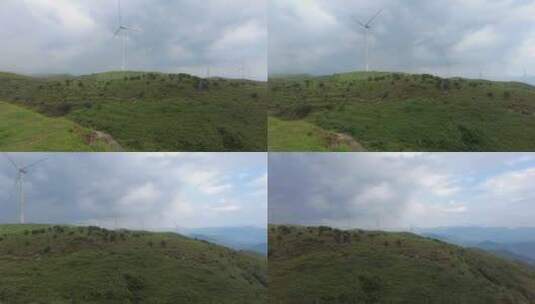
[0,0,267,79]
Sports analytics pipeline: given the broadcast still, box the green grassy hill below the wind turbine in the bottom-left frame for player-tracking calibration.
[0,225,267,304]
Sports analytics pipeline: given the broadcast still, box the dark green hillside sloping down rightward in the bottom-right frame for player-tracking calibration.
[269,226,535,304]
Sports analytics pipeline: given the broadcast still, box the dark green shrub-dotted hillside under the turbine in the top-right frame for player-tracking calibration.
[269,72,535,151]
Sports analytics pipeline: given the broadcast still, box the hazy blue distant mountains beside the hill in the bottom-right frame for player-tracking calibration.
[417,227,535,265]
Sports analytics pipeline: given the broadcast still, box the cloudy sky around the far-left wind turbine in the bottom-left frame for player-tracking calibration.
[0,153,267,229]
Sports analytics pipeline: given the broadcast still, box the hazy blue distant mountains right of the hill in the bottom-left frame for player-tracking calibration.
[177,226,267,255]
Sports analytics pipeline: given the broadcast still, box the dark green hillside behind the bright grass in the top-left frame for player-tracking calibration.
[0,72,267,151]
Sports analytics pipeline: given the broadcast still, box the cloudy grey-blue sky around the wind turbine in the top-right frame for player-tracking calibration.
[269,0,535,79]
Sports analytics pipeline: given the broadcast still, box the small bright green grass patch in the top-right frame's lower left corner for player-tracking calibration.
[268,117,360,152]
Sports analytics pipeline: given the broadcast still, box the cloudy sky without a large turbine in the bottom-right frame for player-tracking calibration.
[269,153,535,230]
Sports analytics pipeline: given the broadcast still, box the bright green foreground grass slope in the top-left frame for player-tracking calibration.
[0,101,113,152]
